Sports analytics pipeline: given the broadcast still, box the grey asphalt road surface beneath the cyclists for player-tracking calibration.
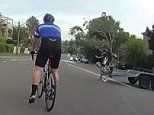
[0,58,154,115]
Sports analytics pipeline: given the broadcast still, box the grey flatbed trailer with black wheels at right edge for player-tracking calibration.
[125,69,154,90]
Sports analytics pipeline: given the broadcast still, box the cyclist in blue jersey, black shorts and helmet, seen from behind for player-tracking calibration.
[28,13,61,103]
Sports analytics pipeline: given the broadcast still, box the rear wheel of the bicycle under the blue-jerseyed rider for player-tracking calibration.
[45,75,56,111]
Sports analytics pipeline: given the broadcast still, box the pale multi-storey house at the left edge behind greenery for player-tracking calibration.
[0,13,13,39]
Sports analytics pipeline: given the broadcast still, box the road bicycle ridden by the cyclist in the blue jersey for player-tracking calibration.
[32,53,56,111]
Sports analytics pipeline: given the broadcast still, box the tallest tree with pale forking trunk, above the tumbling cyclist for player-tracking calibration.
[86,12,123,53]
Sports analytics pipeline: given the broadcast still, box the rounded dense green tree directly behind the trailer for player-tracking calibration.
[120,38,148,68]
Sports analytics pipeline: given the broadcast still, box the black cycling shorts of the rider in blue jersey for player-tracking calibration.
[35,39,61,69]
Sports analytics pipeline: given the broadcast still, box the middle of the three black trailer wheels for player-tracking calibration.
[139,74,150,89]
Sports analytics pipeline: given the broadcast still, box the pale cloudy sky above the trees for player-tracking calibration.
[0,0,154,40]
